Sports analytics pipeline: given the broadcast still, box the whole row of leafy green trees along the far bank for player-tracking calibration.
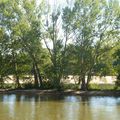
[0,0,120,90]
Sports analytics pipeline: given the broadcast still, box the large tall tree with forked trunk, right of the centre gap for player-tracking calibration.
[62,0,119,90]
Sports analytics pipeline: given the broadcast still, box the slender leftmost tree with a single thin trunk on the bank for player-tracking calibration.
[0,0,24,87]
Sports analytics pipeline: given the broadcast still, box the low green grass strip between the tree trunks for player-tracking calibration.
[0,83,120,91]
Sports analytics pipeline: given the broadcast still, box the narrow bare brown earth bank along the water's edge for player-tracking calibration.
[0,89,120,96]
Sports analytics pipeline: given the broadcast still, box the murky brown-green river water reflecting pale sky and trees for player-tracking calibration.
[0,94,120,120]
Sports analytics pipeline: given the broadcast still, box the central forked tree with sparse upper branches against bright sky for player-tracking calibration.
[43,3,71,88]
